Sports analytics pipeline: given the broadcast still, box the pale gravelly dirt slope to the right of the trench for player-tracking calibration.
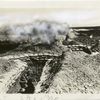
[47,51,100,93]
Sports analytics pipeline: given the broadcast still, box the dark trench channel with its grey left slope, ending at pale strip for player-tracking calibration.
[7,58,46,93]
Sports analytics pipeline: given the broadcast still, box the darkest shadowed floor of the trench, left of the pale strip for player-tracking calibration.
[18,58,46,94]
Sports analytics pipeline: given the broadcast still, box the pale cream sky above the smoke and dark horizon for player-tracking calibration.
[0,0,100,27]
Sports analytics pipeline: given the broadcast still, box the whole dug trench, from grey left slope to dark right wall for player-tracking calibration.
[7,54,61,94]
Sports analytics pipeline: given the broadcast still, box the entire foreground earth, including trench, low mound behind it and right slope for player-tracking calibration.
[0,41,100,93]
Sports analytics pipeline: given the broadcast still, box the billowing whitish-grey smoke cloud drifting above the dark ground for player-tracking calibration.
[0,20,69,44]
